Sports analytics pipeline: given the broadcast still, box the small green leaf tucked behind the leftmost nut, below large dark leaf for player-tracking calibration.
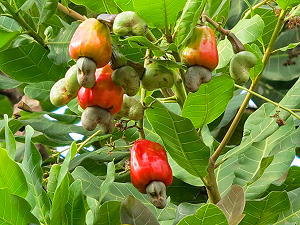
[24,81,54,110]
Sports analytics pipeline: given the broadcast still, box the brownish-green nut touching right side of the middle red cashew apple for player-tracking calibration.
[112,66,140,96]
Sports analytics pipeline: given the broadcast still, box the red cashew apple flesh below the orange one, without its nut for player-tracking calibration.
[77,65,124,114]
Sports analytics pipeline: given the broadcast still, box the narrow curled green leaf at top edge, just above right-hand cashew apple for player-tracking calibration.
[173,0,204,46]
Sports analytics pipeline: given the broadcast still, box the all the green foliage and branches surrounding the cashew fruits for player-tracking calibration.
[0,0,300,225]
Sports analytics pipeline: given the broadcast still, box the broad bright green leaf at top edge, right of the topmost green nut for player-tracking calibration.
[132,0,185,28]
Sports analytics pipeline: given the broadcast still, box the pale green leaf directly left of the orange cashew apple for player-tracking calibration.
[47,22,80,66]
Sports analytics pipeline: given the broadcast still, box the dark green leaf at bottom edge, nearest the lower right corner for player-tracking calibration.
[240,192,290,225]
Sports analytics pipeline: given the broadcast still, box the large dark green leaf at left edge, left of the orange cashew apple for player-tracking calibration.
[0,42,66,82]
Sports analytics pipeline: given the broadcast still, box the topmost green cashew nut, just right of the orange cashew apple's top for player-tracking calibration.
[113,11,148,36]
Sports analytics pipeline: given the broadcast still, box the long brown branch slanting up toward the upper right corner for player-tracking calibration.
[204,10,287,203]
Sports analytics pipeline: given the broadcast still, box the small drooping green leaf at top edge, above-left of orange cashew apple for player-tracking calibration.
[35,0,58,24]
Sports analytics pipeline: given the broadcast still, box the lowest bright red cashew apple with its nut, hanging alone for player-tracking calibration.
[130,139,173,208]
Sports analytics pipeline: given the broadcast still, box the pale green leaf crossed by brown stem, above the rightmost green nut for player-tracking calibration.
[217,15,264,69]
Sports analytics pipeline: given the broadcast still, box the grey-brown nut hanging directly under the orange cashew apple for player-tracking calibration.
[76,57,96,88]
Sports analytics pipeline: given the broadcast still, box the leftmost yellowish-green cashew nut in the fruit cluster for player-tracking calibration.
[50,78,77,107]
